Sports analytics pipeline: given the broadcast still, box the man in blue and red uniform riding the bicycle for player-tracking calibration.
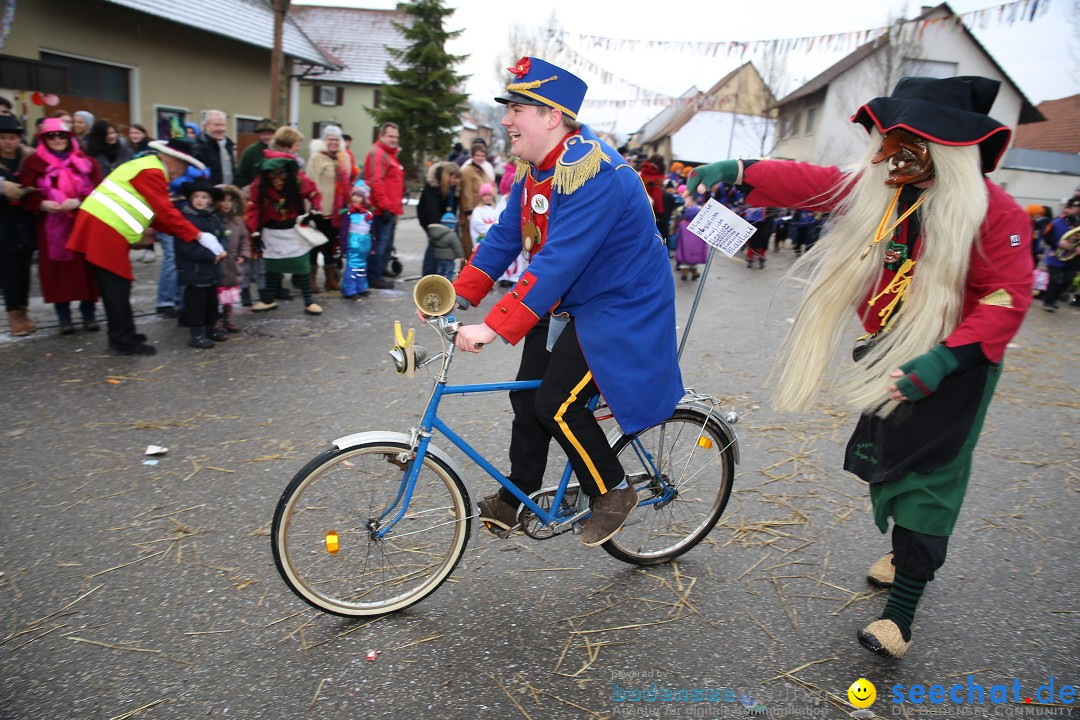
[454,57,684,547]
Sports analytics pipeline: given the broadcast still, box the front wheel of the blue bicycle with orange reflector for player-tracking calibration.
[270,441,472,617]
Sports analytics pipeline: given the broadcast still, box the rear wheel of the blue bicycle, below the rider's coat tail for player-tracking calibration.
[603,409,734,565]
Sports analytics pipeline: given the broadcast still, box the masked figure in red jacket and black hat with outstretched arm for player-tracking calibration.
[689,77,1032,657]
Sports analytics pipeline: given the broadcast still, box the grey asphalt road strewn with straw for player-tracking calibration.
[0,215,1080,720]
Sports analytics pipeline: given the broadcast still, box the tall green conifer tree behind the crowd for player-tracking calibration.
[368,0,469,175]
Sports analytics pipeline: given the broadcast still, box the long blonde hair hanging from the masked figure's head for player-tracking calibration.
[772,131,987,417]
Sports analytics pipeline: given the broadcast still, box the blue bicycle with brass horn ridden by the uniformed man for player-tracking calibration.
[271,287,739,617]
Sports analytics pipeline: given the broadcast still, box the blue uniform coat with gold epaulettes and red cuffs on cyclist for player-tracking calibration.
[455,125,684,433]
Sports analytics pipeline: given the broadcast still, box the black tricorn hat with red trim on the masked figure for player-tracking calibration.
[851,76,1012,173]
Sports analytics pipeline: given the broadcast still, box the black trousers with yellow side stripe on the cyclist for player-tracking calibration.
[500,317,626,506]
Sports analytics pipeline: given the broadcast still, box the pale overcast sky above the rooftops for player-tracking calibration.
[298,0,1080,134]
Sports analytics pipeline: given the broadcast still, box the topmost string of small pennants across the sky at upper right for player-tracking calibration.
[562,0,1050,58]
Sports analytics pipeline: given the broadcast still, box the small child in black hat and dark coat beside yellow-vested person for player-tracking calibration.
[175,178,229,349]
